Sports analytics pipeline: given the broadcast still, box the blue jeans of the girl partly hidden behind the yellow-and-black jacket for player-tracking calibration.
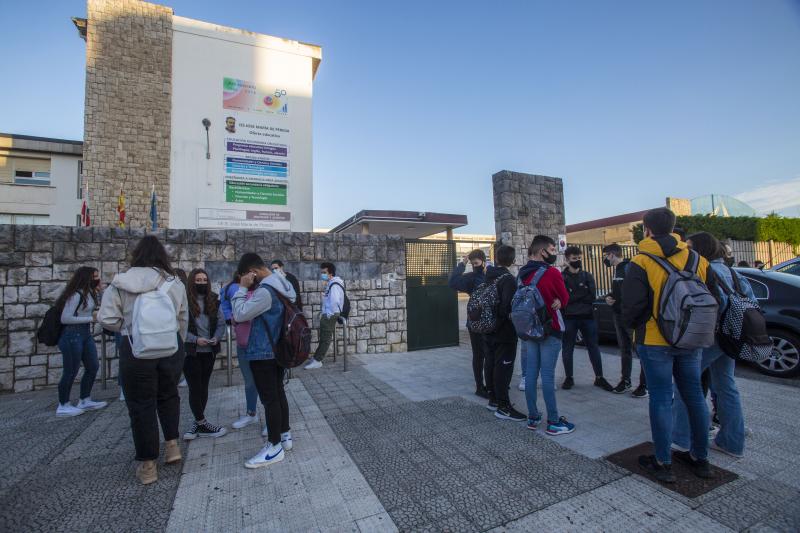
[672,345,744,455]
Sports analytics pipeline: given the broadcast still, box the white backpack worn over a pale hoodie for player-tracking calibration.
[128,278,179,359]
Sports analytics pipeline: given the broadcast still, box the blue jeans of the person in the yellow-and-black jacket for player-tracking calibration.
[637,344,708,464]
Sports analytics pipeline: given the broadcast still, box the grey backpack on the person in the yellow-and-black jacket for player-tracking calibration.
[644,250,719,350]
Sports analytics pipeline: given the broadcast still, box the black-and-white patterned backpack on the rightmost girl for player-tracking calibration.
[717,267,772,363]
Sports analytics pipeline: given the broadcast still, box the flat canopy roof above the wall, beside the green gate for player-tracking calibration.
[330,210,468,239]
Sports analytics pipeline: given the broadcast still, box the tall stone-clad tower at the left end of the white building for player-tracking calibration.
[83,0,172,227]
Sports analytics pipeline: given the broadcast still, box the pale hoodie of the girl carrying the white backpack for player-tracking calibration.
[97,267,189,339]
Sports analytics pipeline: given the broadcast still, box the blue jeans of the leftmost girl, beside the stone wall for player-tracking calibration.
[58,324,100,405]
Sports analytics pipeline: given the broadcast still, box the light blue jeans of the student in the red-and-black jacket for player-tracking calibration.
[522,337,561,422]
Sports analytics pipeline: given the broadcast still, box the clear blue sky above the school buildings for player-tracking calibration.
[0,0,800,233]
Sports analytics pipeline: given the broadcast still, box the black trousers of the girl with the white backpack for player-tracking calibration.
[119,337,184,461]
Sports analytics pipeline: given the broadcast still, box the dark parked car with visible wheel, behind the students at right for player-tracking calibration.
[594,268,800,377]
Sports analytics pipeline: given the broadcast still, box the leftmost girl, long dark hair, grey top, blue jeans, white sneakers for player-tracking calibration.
[56,266,107,417]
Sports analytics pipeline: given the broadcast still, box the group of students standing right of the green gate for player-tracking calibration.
[450,208,755,483]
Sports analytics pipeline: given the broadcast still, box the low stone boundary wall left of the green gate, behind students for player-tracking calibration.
[0,225,407,391]
